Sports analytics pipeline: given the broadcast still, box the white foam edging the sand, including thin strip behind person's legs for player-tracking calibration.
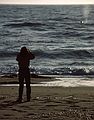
[0,77,94,87]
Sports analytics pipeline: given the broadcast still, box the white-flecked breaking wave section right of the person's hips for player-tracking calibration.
[31,67,94,75]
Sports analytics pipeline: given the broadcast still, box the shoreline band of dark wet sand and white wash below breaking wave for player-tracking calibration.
[0,74,94,87]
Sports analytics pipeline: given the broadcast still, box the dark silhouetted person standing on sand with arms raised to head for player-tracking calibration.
[16,47,35,102]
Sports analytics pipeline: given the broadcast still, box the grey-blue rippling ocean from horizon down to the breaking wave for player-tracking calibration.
[0,5,94,76]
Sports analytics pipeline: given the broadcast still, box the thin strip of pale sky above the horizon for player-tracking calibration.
[0,0,94,4]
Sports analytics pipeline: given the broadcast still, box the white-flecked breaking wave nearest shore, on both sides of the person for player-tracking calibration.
[0,65,94,76]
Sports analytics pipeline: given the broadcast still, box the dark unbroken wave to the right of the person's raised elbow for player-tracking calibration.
[34,49,94,59]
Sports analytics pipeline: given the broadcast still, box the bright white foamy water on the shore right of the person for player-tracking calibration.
[39,77,94,87]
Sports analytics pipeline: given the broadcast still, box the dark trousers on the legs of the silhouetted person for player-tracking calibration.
[19,69,31,101]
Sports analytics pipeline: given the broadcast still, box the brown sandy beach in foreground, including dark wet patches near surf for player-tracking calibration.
[0,77,94,120]
